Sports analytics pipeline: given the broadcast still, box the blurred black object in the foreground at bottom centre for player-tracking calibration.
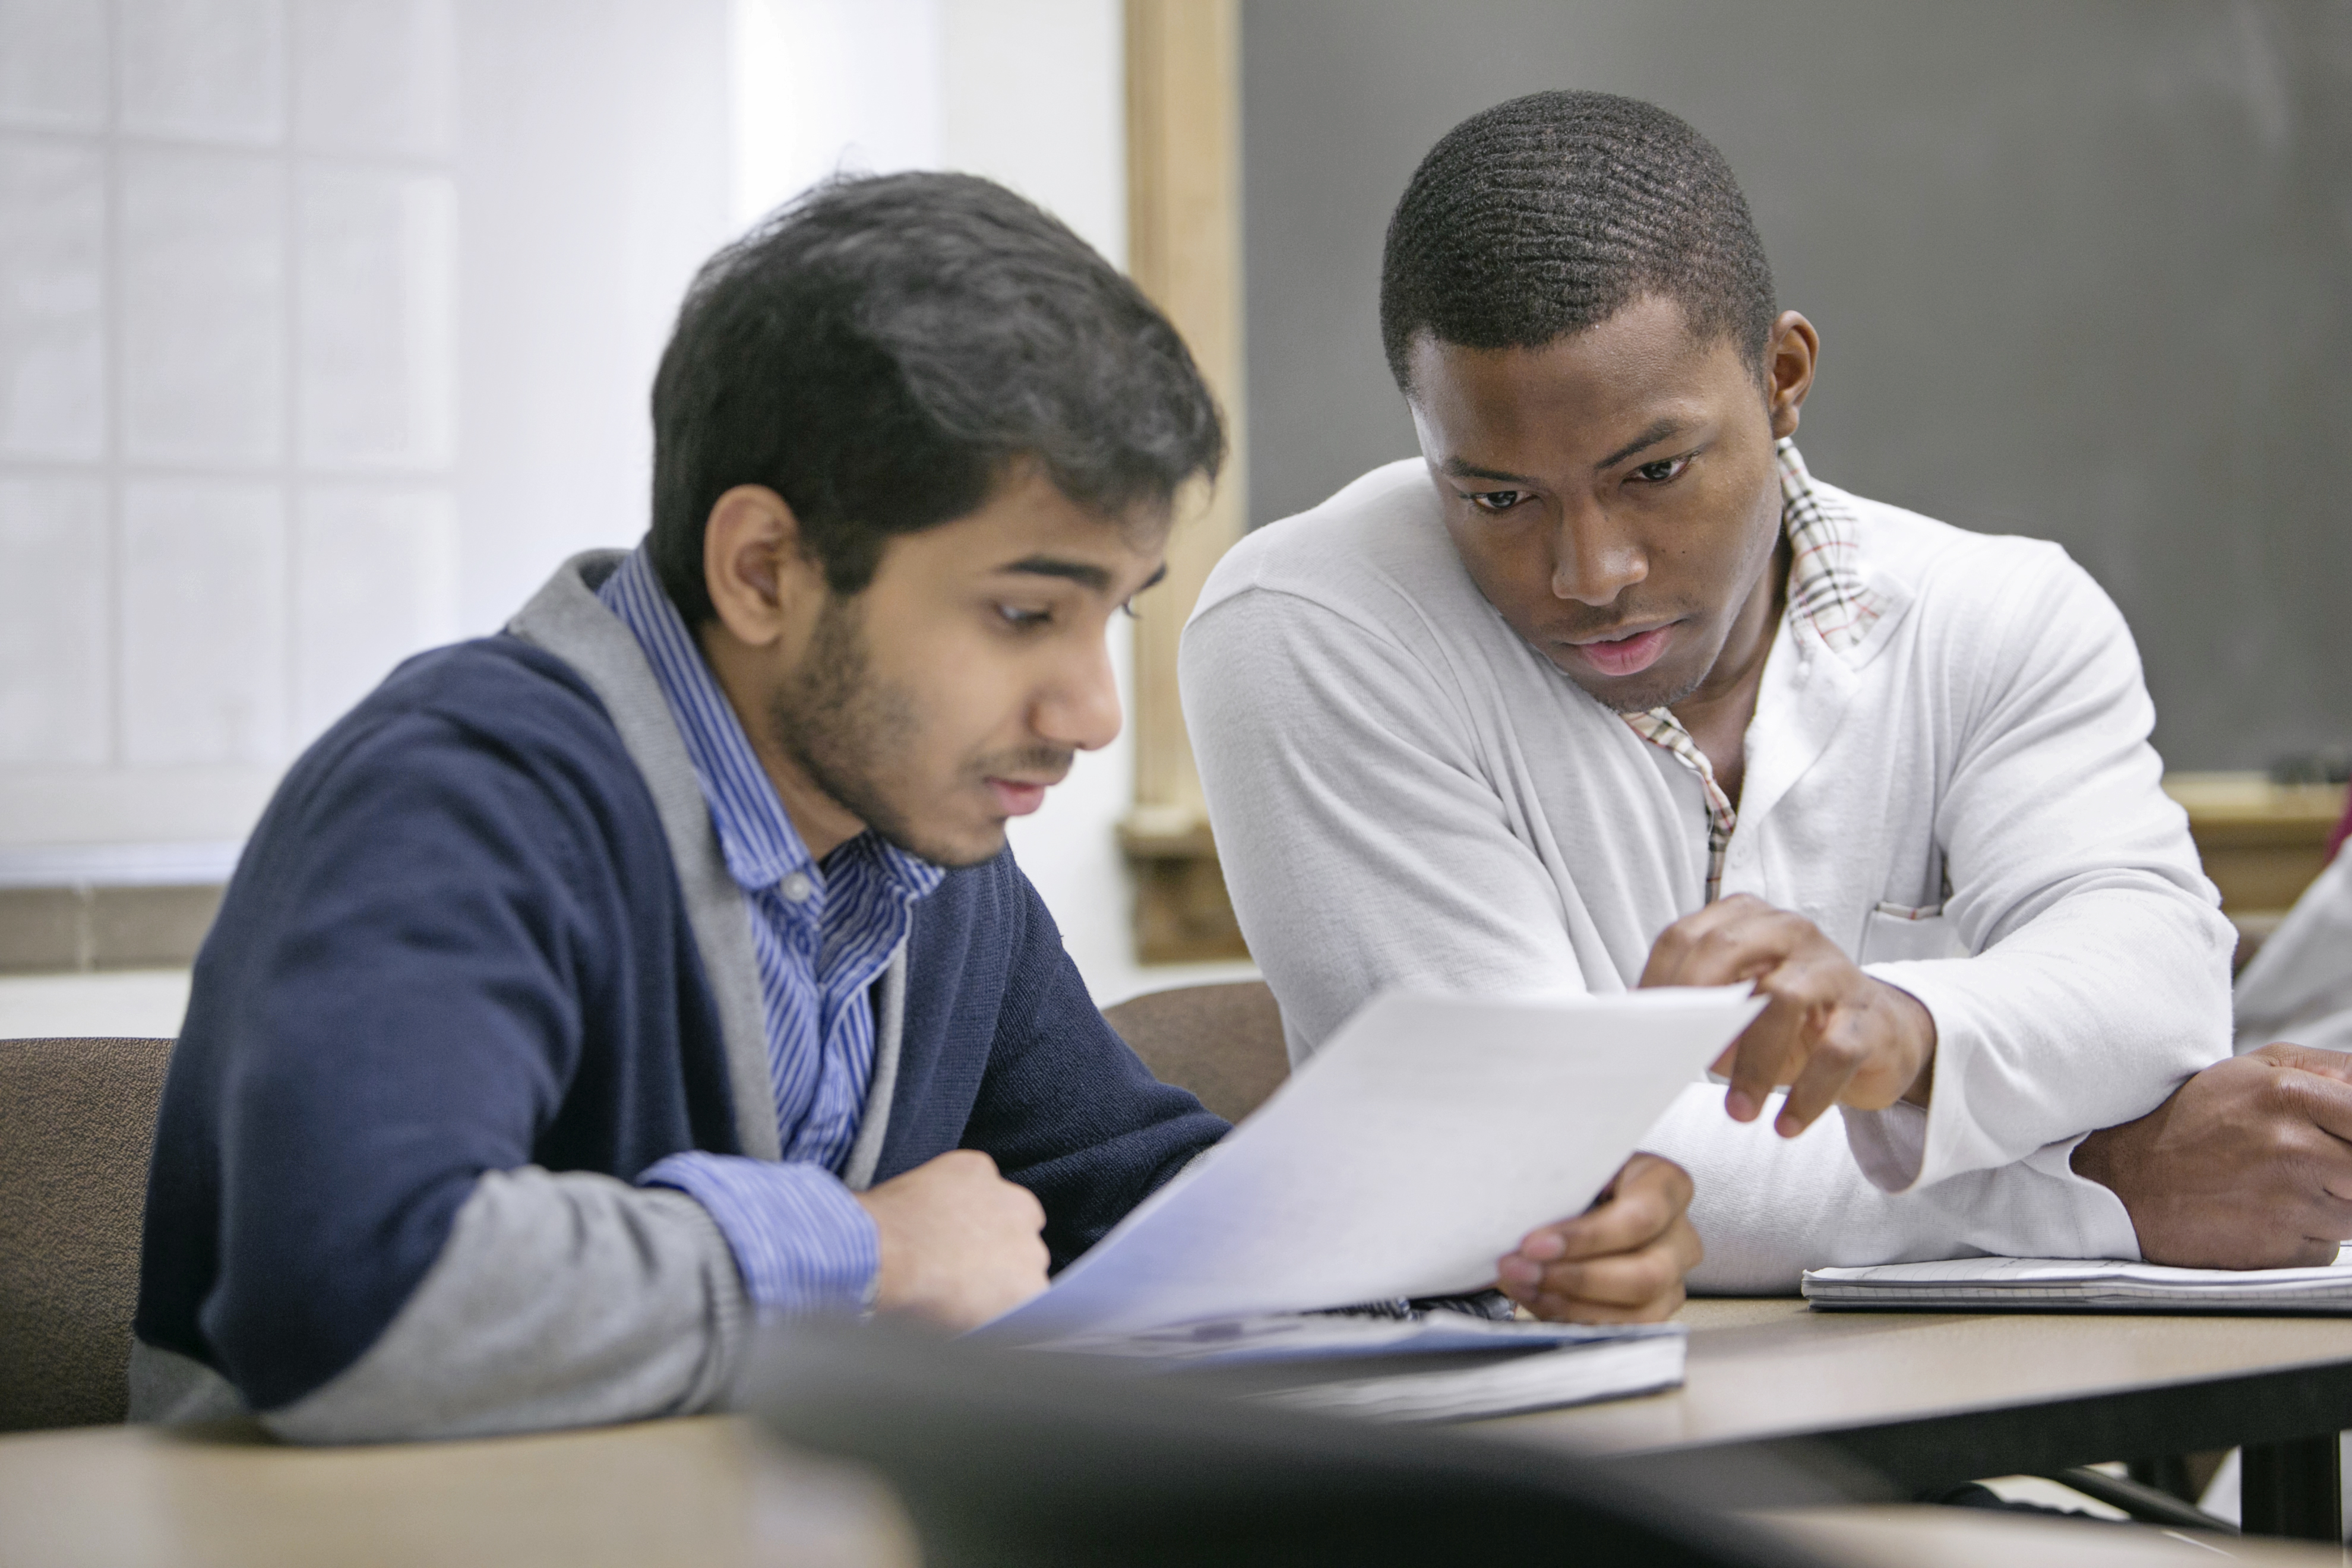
[738,1323,1818,1568]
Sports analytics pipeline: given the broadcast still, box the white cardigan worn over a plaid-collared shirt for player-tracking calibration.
[1181,461,2234,1288]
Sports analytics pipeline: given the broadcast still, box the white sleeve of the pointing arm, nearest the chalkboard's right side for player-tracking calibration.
[1844,548,2237,1190]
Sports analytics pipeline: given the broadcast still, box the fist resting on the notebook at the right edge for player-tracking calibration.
[2075,1044,2352,1269]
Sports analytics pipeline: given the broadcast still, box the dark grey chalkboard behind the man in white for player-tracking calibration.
[1242,0,2352,769]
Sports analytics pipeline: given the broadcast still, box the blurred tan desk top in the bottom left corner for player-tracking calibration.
[0,1415,919,1568]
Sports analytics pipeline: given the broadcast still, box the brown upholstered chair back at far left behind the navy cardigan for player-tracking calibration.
[0,1039,172,1431]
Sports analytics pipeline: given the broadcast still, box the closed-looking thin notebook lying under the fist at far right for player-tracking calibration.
[1804,1253,2352,1316]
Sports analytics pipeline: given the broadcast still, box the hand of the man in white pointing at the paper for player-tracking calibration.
[1642,893,1936,1138]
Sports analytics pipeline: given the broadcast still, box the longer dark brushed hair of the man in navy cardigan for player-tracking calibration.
[652,174,1225,625]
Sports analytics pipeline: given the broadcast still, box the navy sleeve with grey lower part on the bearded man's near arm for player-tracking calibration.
[139,684,748,1441]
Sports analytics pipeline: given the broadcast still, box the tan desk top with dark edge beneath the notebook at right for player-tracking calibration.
[1480,1298,2352,1481]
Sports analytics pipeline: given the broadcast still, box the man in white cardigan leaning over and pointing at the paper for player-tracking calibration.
[1181,94,2352,1319]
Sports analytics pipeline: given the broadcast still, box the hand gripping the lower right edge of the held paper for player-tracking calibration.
[1496,1154,1700,1323]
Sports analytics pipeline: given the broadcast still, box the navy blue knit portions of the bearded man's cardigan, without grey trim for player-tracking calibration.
[137,635,1225,1411]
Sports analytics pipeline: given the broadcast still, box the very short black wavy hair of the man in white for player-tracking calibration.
[1381,91,1776,395]
